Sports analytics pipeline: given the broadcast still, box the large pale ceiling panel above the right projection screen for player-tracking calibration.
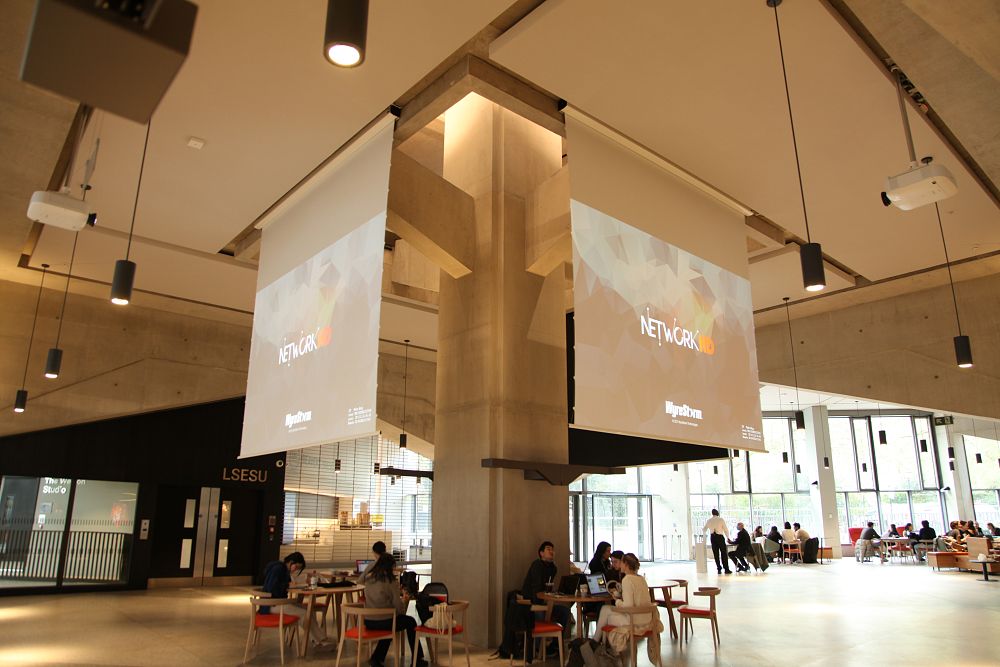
[490,0,1000,298]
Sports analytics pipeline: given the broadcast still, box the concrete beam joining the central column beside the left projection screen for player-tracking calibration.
[387,151,475,278]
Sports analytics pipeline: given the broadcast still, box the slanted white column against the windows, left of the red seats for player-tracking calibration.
[800,405,842,558]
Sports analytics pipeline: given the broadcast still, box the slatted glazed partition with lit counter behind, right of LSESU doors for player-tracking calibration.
[281,436,433,567]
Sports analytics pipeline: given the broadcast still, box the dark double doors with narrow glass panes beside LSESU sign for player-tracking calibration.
[150,486,261,586]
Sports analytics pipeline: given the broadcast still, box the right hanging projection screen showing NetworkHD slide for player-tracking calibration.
[567,112,764,451]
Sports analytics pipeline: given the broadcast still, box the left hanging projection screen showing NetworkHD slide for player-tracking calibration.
[240,118,392,457]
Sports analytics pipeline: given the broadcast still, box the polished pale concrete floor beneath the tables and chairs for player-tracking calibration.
[0,559,1000,667]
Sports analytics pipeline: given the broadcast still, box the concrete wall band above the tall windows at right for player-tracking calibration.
[757,275,1000,418]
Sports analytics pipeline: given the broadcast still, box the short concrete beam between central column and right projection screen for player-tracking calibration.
[524,167,573,277]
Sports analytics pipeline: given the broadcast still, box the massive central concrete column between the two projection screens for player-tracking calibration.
[433,95,569,646]
